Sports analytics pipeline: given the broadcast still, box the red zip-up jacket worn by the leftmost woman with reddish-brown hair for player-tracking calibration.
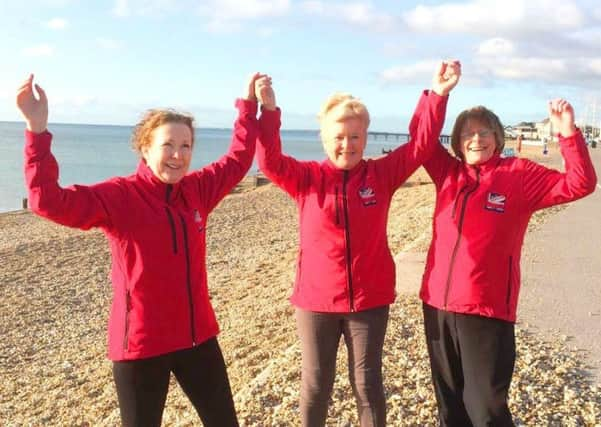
[25,100,257,360]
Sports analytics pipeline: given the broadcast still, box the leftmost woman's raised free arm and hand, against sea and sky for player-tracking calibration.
[16,75,120,229]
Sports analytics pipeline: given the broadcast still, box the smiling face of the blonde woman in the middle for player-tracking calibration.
[321,117,367,170]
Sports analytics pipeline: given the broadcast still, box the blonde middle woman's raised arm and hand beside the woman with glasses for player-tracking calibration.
[386,60,461,188]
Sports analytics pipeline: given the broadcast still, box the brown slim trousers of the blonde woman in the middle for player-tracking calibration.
[296,306,389,427]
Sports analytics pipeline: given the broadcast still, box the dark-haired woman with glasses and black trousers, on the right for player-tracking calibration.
[412,99,597,427]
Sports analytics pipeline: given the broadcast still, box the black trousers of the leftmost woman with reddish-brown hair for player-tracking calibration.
[113,338,238,427]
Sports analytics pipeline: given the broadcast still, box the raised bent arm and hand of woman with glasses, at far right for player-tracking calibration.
[524,99,597,210]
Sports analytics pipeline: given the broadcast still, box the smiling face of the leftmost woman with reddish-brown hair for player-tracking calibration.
[141,123,192,184]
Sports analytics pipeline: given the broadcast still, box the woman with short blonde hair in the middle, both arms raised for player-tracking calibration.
[255,61,460,427]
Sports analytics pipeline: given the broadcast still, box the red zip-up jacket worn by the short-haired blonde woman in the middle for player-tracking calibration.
[257,93,448,313]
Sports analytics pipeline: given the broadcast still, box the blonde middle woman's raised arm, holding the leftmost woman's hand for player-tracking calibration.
[256,76,308,197]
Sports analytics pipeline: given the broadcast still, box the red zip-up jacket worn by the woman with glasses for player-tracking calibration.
[420,132,597,322]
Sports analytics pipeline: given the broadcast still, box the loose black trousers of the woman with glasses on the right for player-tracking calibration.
[423,304,515,427]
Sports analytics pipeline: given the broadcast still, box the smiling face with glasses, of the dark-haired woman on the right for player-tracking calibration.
[459,119,497,165]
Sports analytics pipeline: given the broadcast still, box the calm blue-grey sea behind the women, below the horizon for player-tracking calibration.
[0,122,404,212]
